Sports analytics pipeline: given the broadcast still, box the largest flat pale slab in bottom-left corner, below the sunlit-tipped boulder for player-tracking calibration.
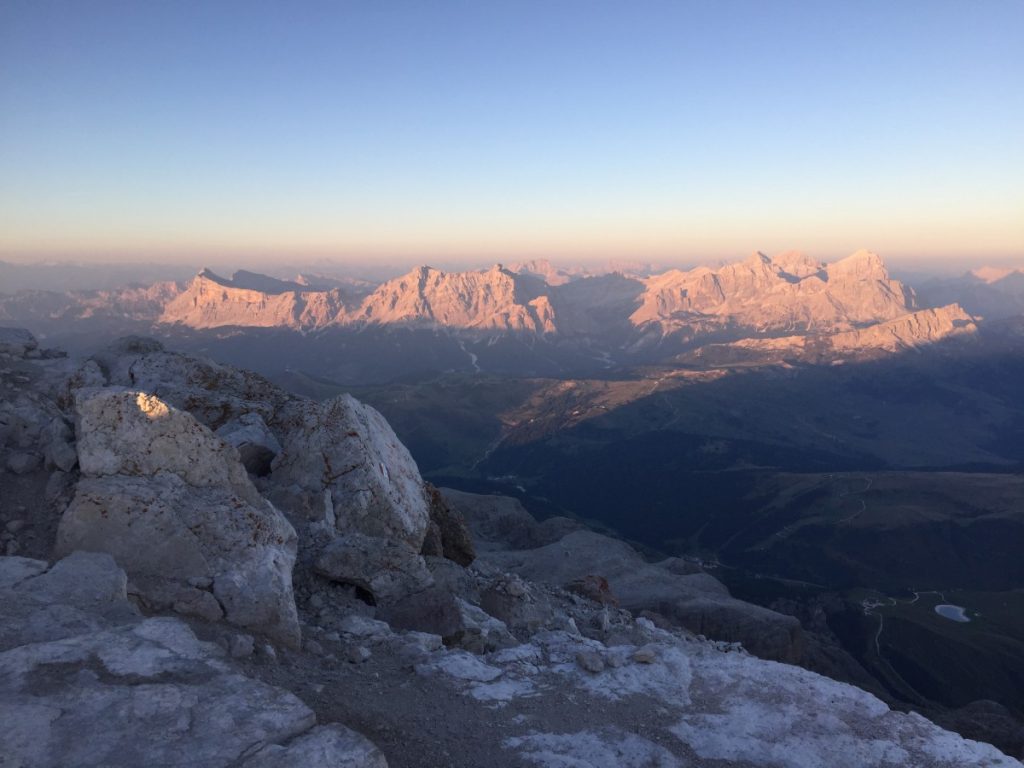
[0,618,376,768]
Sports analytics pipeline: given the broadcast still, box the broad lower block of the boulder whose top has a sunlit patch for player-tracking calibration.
[55,474,299,645]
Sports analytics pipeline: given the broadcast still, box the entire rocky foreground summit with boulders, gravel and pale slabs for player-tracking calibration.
[0,329,1020,768]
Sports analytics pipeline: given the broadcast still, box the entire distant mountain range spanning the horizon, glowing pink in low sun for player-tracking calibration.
[0,251,983,358]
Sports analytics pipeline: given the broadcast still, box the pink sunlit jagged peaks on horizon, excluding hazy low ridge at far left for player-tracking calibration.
[153,251,973,349]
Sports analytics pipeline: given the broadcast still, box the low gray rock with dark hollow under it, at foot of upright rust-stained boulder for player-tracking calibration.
[313,534,433,605]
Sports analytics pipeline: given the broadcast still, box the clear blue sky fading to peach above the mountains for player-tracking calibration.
[0,0,1024,264]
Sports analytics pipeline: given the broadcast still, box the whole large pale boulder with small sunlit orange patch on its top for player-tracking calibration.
[55,388,299,645]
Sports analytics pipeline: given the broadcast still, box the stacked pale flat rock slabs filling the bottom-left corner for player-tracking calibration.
[0,553,386,768]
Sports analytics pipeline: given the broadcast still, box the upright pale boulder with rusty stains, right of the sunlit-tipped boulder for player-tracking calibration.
[270,394,430,554]
